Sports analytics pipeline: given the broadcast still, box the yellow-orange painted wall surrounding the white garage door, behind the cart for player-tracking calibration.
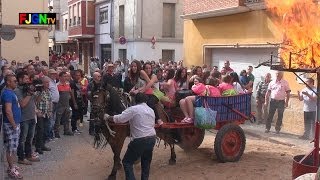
[183,10,304,94]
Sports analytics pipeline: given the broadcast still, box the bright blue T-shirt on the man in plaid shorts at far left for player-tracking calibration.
[1,89,21,124]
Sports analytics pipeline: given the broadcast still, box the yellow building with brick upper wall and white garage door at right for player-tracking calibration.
[182,0,316,134]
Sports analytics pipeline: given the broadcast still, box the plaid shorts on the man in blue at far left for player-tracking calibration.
[3,123,20,154]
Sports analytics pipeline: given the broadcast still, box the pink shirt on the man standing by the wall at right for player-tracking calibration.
[268,79,291,100]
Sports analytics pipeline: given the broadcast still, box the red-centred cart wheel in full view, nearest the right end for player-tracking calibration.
[214,124,246,162]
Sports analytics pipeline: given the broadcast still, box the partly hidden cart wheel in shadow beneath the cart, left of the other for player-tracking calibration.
[178,127,205,151]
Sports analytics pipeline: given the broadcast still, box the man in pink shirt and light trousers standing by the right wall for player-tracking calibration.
[265,71,291,134]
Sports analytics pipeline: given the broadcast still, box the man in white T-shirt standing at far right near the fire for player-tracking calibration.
[298,78,317,139]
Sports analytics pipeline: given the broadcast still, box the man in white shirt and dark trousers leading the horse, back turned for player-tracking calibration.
[105,93,156,180]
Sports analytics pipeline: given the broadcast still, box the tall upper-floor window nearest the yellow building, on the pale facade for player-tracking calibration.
[162,3,176,37]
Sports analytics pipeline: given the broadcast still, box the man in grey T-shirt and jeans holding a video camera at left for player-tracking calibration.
[15,72,40,165]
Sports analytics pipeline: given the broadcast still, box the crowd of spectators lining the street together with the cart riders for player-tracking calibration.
[0,54,314,178]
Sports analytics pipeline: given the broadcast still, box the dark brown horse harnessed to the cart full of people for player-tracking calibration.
[91,87,177,180]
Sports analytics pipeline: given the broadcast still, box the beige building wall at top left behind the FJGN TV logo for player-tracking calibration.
[1,0,49,62]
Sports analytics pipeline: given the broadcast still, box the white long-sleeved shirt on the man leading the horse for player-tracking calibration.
[113,103,156,139]
